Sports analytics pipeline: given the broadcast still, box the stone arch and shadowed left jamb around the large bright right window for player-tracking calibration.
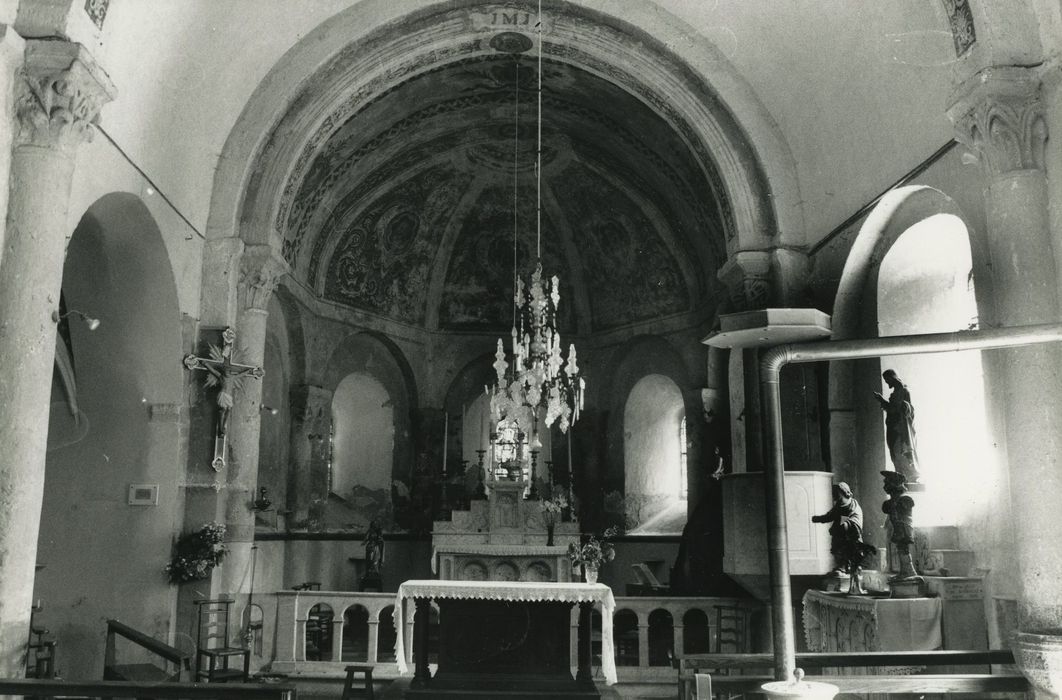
[828,186,992,531]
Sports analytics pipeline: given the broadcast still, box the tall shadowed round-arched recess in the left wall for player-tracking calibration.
[39,192,182,679]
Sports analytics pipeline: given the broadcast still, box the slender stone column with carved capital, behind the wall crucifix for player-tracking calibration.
[221,245,288,595]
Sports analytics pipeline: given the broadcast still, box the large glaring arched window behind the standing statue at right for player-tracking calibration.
[877,215,994,526]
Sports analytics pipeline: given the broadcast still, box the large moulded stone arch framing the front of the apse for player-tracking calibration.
[207,0,804,266]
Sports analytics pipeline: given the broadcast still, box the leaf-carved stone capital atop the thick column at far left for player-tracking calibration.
[15,39,115,148]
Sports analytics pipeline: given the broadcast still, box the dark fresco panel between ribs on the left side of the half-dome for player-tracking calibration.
[324,165,468,323]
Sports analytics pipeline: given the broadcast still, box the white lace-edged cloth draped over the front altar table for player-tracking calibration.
[395,580,616,685]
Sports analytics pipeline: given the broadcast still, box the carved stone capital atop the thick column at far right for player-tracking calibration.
[947,66,1047,175]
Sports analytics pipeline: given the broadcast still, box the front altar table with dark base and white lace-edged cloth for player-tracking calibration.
[395,581,616,700]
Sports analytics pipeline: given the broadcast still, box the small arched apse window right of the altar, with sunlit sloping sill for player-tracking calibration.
[623,374,686,534]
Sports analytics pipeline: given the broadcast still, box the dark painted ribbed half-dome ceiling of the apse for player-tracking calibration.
[282,48,725,335]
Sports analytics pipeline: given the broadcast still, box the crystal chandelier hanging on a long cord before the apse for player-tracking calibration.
[487,1,586,449]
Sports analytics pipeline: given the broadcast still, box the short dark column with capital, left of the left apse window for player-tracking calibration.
[288,385,332,523]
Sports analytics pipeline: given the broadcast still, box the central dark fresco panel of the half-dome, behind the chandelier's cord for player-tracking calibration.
[439,185,576,332]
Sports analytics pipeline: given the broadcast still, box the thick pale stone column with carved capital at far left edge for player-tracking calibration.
[0,40,114,678]
